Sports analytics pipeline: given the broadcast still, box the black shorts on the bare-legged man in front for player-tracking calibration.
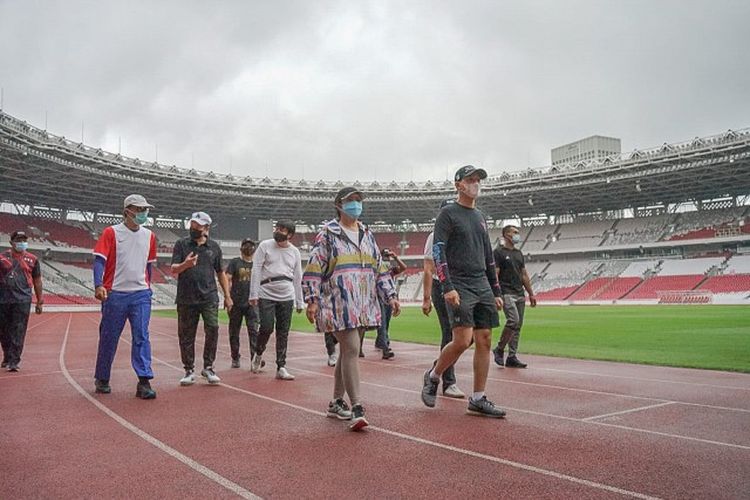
[446,280,500,329]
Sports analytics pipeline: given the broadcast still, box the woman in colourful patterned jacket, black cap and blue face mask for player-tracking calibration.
[302,187,400,431]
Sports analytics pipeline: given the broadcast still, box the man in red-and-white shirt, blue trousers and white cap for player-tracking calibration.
[94,194,156,399]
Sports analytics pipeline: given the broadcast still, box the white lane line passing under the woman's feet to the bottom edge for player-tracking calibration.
[140,340,658,500]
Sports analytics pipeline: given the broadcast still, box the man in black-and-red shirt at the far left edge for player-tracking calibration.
[0,231,44,372]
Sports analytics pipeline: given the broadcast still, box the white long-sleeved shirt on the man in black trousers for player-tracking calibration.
[250,239,305,309]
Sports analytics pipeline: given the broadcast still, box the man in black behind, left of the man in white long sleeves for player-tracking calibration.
[225,238,258,368]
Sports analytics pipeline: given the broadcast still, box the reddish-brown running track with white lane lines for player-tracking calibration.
[0,313,750,499]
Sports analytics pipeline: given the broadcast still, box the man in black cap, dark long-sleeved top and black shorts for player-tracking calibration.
[422,165,505,418]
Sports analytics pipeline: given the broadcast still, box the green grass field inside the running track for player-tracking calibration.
[155,306,750,372]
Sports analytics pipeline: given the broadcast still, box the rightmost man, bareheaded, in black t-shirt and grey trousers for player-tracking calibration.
[492,226,536,368]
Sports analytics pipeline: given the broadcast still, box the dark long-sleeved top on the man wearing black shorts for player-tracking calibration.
[433,203,500,297]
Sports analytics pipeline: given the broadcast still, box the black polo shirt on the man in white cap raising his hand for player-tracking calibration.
[172,238,222,304]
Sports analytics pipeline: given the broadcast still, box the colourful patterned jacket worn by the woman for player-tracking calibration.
[302,220,396,332]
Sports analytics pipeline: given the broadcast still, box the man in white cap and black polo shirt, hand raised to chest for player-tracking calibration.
[172,212,232,386]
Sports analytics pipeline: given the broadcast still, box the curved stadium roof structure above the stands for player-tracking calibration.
[0,111,750,224]
